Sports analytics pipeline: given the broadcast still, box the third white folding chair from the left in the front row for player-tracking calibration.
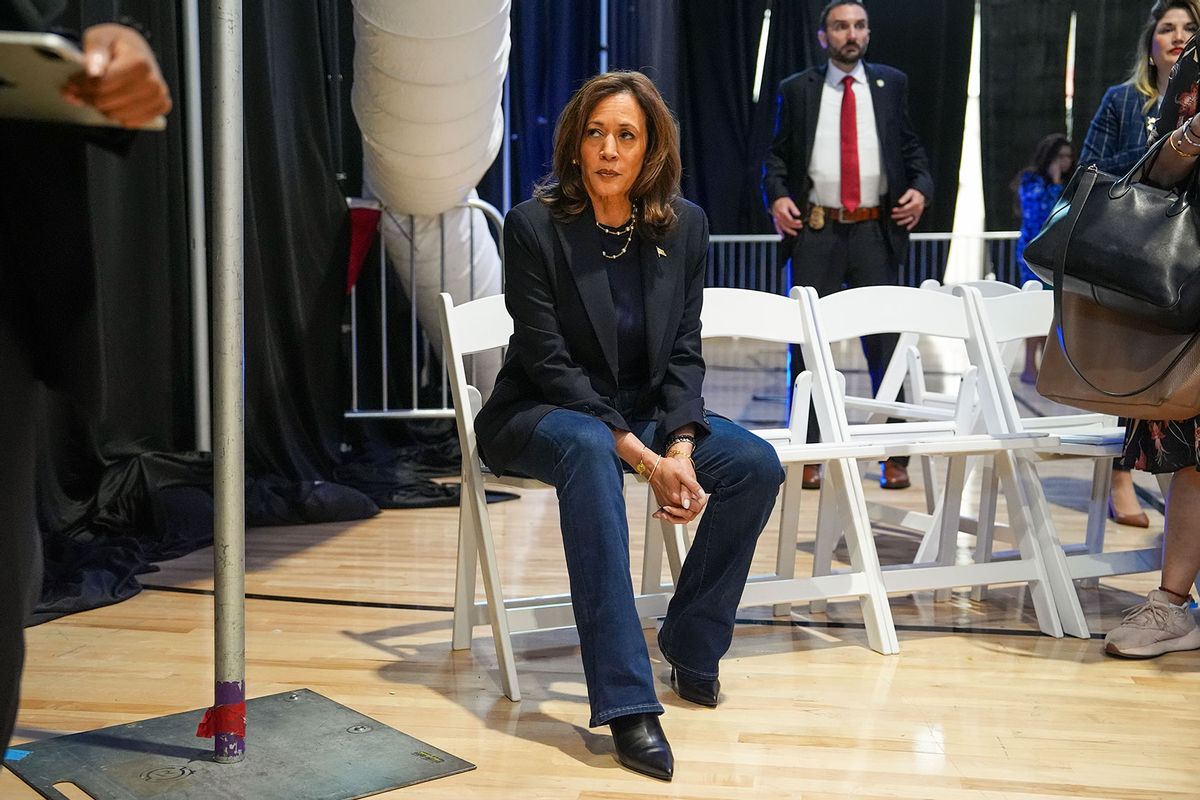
[792,287,1087,636]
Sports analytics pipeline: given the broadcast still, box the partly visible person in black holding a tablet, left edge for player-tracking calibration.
[0,0,170,751]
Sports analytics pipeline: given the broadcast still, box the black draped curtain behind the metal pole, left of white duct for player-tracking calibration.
[38,0,378,619]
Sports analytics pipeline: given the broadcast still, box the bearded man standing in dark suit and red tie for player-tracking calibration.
[762,0,934,489]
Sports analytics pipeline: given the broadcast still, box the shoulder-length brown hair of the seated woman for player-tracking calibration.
[533,70,682,237]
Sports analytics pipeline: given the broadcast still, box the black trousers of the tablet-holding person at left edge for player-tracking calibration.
[0,298,42,751]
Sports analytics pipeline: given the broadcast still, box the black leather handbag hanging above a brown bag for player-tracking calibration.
[1025,137,1200,332]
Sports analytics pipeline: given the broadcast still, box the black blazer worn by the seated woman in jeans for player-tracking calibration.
[475,199,708,474]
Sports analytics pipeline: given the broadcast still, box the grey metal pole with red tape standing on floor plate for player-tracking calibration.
[212,0,246,764]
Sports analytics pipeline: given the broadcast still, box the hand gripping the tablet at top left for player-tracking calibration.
[62,23,170,127]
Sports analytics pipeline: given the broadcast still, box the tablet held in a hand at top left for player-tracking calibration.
[0,31,167,131]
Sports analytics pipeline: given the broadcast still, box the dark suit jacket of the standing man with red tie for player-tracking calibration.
[762,61,934,263]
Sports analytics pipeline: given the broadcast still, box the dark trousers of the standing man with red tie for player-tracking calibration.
[781,217,908,464]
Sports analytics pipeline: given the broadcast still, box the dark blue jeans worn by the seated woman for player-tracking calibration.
[511,409,784,727]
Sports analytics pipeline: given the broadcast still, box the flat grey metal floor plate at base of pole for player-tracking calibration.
[5,688,475,800]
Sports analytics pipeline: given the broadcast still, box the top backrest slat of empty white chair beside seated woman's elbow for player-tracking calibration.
[700,288,804,344]
